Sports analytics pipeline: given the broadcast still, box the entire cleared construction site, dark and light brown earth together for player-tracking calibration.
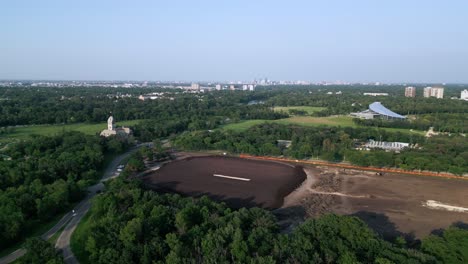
[143,153,468,240]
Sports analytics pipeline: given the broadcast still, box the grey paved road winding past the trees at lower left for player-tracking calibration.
[0,143,151,264]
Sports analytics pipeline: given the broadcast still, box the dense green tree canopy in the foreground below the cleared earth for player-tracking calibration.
[70,179,468,263]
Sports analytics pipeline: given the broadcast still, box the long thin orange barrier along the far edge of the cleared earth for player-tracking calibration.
[239,154,468,180]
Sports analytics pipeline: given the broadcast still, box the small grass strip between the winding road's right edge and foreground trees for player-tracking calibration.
[70,210,91,264]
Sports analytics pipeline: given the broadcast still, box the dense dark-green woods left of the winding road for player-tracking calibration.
[0,132,125,250]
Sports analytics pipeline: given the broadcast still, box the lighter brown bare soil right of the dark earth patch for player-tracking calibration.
[288,167,468,238]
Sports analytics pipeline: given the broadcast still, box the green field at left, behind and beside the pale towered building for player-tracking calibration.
[0,119,143,143]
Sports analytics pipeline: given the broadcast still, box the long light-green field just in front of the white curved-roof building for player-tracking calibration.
[223,116,425,135]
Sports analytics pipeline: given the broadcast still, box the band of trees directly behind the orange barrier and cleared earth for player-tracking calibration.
[174,123,468,175]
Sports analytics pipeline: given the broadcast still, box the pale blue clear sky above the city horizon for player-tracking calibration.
[0,0,468,83]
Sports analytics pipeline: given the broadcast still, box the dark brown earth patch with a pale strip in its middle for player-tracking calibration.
[142,156,306,209]
